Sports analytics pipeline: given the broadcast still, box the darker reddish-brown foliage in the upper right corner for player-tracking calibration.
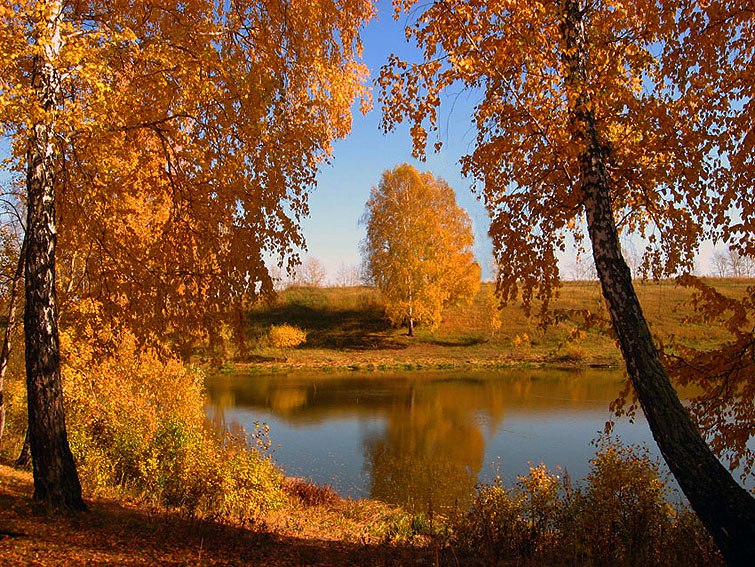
[663,0,755,256]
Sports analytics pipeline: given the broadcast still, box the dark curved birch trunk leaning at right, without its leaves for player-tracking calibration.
[562,0,755,565]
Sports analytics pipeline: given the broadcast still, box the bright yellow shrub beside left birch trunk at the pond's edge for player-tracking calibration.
[62,326,284,520]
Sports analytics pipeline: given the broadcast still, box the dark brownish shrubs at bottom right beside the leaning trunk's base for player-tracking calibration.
[455,440,723,566]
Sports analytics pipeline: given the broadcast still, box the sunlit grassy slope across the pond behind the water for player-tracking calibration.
[227,280,753,371]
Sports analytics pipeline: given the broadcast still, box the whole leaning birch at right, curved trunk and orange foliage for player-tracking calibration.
[380,0,755,565]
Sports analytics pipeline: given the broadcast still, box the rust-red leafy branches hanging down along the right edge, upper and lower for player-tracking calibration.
[632,5,755,496]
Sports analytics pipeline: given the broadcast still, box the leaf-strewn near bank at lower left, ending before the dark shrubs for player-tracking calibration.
[0,465,437,567]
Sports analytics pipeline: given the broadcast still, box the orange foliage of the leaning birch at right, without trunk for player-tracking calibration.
[379,0,755,309]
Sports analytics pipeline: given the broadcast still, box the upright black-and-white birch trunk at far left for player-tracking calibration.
[24,0,86,510]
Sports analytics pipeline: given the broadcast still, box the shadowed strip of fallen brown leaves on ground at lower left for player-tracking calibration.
[0,466,448,566]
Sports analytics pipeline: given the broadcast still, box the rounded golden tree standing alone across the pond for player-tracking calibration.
[363,164,480,336]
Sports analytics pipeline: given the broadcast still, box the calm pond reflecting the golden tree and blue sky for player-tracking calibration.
[206,370,696,512]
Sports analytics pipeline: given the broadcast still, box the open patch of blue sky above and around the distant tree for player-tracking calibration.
[303,1,500,278]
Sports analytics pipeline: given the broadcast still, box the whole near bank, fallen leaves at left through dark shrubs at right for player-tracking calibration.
[0,445,723,567]
